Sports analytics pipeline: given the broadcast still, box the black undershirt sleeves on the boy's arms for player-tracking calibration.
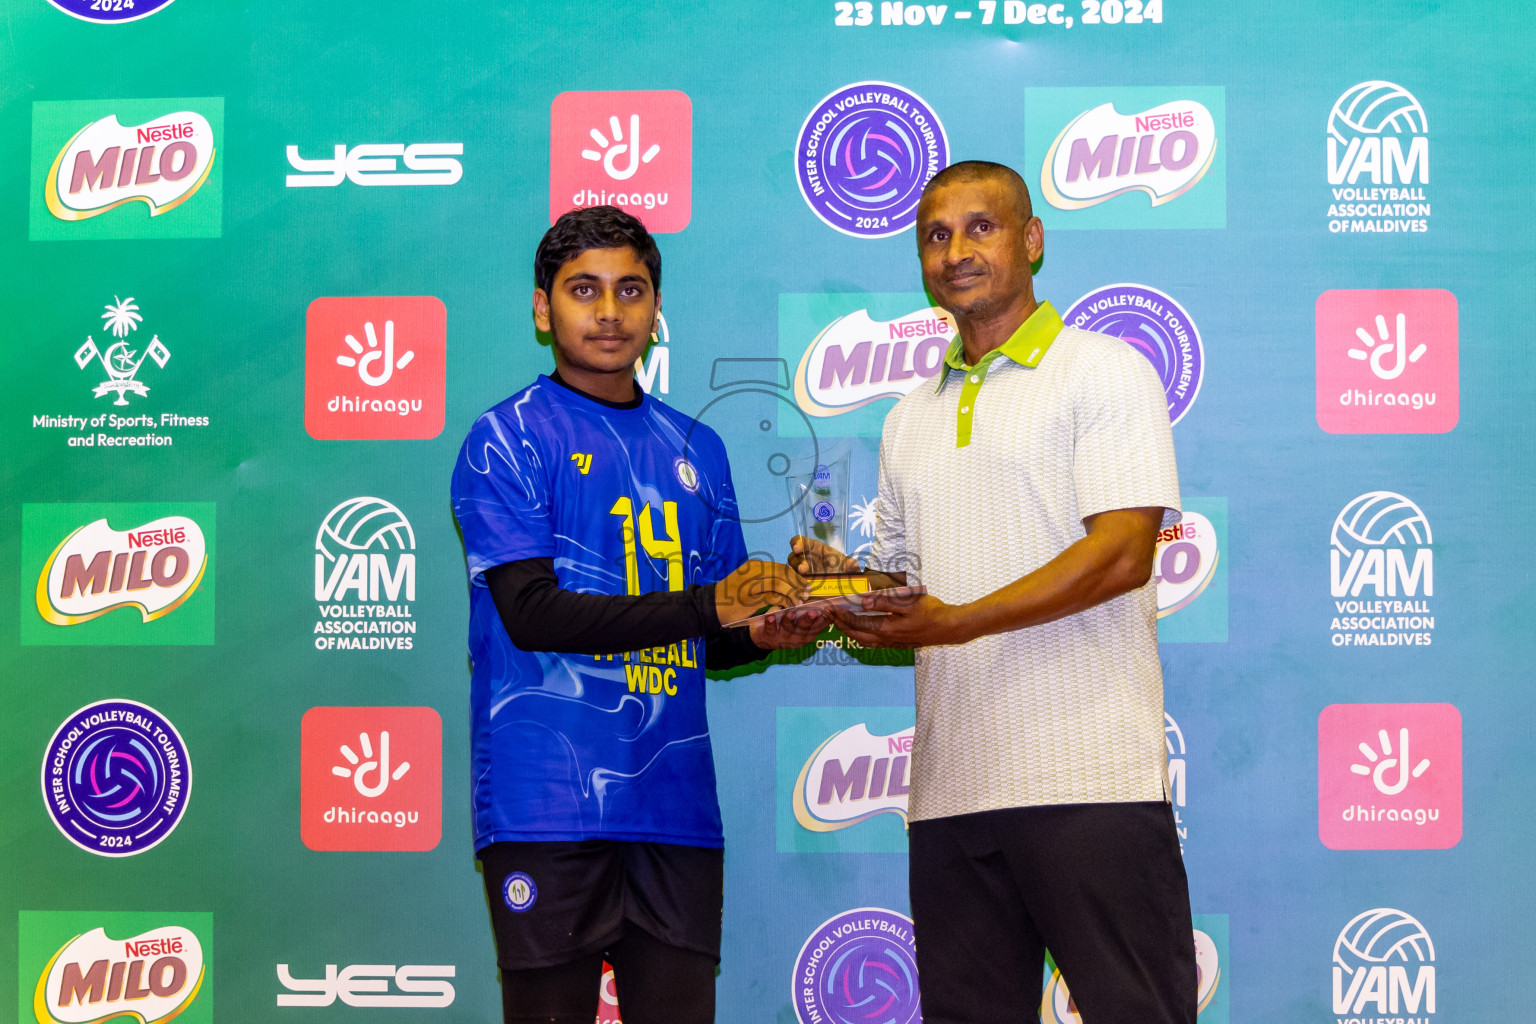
[485,559,768,669]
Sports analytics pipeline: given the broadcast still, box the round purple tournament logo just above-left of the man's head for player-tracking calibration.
[794,81,949,238]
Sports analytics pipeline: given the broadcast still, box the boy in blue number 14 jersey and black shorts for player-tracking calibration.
[453,207,826,1024]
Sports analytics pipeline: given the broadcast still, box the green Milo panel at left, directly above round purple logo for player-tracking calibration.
[22,502,214,645]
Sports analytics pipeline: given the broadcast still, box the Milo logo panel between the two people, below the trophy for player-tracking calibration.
[776,708,914,854]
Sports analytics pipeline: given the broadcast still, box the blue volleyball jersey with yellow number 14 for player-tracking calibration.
[453,376,746,849]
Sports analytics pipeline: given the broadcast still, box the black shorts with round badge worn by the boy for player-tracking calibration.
[476,840,725,970]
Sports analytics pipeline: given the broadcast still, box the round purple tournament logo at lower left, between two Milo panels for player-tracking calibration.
[43,700,192,857]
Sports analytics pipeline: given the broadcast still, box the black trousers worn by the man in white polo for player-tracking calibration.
[909,803,1200,1024]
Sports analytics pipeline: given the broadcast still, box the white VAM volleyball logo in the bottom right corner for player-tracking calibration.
[1333,907,1436,1024]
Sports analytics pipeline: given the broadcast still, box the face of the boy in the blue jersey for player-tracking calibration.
[533,246,660,380]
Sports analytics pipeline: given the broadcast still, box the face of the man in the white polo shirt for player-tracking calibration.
[917,178,1044,316]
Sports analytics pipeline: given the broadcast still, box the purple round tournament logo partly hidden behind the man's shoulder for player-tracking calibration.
[1061,284,1206,424]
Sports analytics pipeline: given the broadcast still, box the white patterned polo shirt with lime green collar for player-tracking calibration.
[869,302,1181,820]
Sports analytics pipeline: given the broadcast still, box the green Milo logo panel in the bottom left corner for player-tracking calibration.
[17,910,214,1024]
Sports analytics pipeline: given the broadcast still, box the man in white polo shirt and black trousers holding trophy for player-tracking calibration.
[811,161,1197,1024]
